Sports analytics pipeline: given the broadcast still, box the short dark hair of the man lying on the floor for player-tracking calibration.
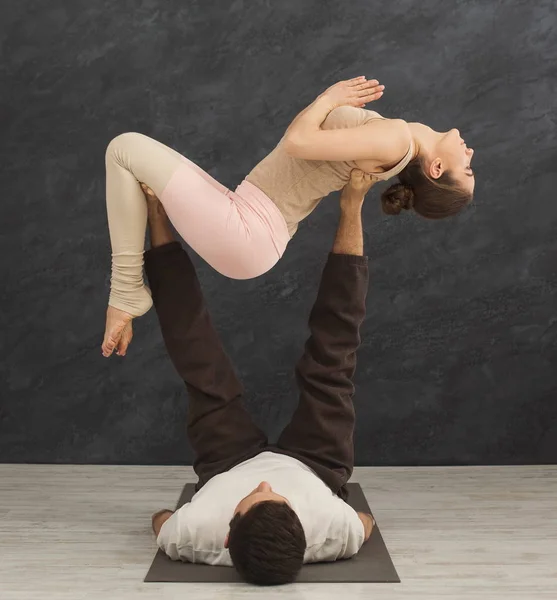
[228,500,306,585]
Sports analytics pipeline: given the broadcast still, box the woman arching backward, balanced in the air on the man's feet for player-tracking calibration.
[102,77,474,356]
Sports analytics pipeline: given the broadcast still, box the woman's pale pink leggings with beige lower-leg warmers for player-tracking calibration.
[106,133,290,317]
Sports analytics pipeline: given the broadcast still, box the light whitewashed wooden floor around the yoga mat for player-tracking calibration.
[0,465,557,600]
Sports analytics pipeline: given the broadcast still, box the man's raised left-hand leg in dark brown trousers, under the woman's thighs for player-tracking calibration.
[145,186,267,489]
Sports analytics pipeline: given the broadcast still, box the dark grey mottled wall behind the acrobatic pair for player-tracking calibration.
[0,0,557,465]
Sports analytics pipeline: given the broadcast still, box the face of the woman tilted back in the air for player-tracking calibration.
[430,129,476,193]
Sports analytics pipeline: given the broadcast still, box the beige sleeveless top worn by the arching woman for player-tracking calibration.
[246,106,413,237]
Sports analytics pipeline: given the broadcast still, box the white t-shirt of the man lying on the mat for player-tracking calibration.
[157,451,365,566]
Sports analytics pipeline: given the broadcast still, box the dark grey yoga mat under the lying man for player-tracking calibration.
[145,483,400,583]
